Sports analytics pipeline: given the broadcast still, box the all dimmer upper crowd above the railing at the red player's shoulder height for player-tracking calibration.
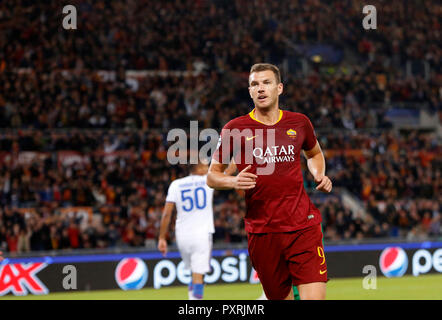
[0,0,442,129]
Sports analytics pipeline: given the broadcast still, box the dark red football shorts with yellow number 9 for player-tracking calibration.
[248,224,328,300]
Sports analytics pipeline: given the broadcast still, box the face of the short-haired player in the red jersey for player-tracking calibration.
[249,70,283,109]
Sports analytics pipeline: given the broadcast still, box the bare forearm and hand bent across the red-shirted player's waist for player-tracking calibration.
[207,159,258,190]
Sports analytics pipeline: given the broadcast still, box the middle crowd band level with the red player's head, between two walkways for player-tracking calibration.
[0,66,441,130]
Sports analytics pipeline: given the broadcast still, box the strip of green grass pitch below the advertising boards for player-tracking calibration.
[0,274,442,300]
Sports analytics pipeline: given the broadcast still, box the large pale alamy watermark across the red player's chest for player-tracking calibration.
[167,121,299,175]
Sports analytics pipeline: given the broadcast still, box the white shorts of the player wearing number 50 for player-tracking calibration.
[176,233,212,274]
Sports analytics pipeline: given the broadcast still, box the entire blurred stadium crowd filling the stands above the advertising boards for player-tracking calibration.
[0,0,442,252]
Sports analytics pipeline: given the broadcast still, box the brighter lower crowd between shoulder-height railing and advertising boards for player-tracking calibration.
[0,130,442,251]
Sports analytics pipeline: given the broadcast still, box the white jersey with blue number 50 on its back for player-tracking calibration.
[166,175,215,235]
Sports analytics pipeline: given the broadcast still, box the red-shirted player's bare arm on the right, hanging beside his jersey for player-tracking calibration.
[304,140,332,192]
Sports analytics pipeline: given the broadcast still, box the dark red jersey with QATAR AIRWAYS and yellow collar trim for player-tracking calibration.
[213,110,322,233]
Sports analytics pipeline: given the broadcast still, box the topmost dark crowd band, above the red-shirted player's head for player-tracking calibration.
[0,0,442,73]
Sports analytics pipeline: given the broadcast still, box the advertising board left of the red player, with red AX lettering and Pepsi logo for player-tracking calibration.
[0,250,259,295]
